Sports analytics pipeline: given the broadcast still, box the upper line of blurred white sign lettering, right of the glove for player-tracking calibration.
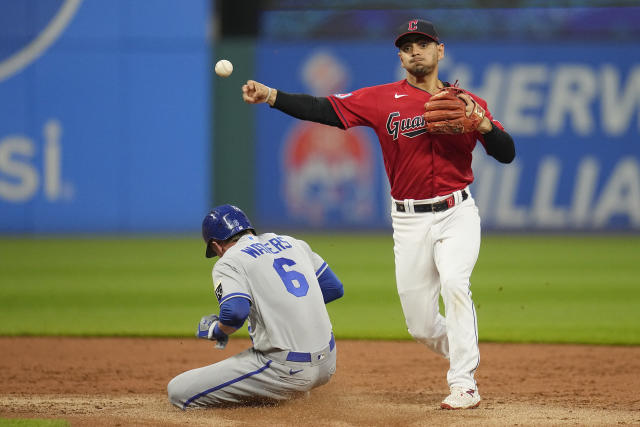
[443,57,640,137]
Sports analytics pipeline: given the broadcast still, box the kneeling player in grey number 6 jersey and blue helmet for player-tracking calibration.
[167,205,343,409]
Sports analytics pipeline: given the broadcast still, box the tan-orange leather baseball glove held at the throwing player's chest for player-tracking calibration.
[423,87,485,134]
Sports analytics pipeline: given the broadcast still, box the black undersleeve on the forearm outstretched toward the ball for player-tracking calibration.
[273,89,344,129]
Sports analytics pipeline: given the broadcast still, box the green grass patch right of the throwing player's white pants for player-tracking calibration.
[472,236,640,344]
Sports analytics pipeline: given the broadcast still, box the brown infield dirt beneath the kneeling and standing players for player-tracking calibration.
[0,338,640,427]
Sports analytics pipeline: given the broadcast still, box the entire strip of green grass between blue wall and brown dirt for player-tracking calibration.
[0,233,640,345]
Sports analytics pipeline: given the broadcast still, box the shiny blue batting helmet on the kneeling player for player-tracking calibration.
[202,205,255,258]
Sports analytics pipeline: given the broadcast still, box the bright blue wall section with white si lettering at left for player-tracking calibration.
[0,0,211,232]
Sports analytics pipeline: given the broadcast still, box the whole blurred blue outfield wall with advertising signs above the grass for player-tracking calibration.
[0,0,640,235]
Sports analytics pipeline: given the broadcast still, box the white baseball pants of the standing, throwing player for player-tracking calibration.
[391,188,480,389]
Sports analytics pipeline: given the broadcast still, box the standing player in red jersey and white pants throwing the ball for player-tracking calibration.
[242,19,515,409]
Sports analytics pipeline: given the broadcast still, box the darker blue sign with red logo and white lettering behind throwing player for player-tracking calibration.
[256,41,640,231]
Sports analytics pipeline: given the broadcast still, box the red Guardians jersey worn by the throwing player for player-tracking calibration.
[328,80,504,200]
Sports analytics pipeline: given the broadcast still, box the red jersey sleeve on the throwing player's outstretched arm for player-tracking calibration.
[327,87,379,129]
